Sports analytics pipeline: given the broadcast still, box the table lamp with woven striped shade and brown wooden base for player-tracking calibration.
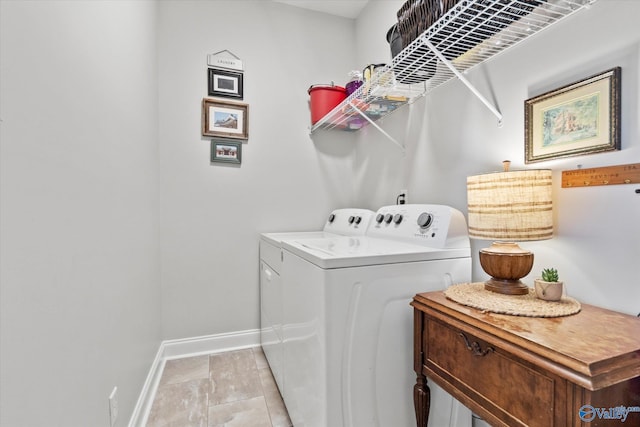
[467,161,553,295]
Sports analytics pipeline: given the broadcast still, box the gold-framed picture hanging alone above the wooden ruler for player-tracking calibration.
[524,67,621,163]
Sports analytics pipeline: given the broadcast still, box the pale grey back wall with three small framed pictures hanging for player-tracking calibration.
[158,1,355,339]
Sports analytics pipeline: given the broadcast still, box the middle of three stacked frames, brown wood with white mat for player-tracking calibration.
[202,98,249,139]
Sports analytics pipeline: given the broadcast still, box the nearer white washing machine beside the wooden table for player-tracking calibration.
[281,205,471,427]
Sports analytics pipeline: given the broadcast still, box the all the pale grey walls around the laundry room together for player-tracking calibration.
[0,0,640,427]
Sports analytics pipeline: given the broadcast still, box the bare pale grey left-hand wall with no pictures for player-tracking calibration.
[0,0,160,427]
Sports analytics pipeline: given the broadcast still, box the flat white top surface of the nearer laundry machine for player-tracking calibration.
[282,236,471,269]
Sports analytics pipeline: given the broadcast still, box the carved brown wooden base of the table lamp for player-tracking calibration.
[480,242,533,295]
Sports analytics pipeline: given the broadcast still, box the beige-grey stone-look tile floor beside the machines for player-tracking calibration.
[146,347,292,427]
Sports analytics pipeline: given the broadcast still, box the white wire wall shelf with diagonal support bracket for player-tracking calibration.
[311,0,597,135]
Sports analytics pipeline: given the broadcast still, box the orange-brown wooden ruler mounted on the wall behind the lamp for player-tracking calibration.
[562,163,640,188]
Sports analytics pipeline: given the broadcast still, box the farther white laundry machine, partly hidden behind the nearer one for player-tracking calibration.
[259,209,375,393]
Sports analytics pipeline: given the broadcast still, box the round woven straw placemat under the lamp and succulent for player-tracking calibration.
[444,283,581,317]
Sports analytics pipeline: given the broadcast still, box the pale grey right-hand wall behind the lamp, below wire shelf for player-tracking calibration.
[355,0,640,314]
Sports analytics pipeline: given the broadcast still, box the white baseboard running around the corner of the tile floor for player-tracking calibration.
[129,329,260,427]
